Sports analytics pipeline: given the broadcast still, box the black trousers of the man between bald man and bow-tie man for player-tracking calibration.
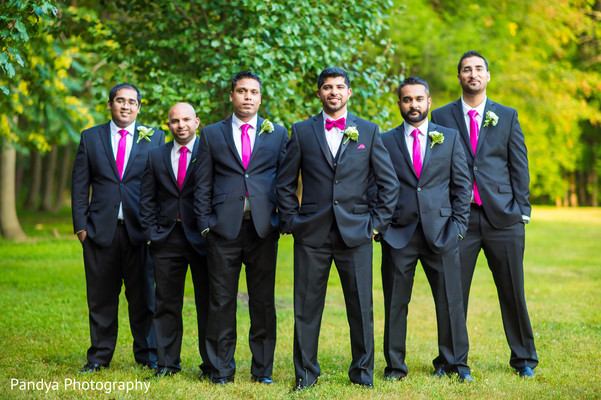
[206,220,279,377]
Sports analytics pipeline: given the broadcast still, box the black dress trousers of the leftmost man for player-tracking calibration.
[82,224,156,364]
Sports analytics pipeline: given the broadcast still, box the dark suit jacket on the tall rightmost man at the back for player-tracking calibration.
[432,99,531,228]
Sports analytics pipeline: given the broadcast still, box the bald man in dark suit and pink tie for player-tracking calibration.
[140,103,214,376]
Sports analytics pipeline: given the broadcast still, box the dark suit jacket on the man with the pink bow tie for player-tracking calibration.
[276,113,399,247]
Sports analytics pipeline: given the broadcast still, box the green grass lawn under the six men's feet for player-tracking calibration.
[0,207,601,400]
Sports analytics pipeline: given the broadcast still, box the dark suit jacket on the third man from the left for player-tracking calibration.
[195,117,288,240]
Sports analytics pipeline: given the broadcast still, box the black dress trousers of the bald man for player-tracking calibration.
[152,222,214,374]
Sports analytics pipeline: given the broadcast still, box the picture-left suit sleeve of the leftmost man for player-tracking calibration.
[71,133,90,233]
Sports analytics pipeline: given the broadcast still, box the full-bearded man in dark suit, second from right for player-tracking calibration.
[381,78,473,382]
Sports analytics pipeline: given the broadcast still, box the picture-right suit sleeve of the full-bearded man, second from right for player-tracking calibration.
[449,134,472,236]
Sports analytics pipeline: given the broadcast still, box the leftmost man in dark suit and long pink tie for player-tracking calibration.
[71,83,165,372]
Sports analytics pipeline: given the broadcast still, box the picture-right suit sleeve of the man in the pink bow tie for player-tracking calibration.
[368,126,399,232]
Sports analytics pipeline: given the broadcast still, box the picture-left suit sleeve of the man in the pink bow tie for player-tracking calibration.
[276,125,301,233]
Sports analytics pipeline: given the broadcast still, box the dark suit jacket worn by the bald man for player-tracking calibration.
[140,138,206,254]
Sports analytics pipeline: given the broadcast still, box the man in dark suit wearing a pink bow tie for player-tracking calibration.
[276,68,399,390]
